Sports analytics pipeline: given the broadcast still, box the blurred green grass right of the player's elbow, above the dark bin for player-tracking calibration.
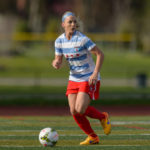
[102,51,150,78]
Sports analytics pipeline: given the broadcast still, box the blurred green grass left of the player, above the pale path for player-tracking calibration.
[0,44,68,78]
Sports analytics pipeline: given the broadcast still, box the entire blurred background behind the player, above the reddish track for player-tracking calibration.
[0,0,150,106]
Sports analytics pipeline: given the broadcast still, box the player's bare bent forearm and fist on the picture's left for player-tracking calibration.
[52,55,63,69]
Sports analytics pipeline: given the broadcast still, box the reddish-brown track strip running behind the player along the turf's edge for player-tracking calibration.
[0,106,150,116]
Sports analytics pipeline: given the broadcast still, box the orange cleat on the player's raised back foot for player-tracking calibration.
[101,112,111,135]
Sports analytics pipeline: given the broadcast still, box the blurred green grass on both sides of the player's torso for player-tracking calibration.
[0,43,150,78]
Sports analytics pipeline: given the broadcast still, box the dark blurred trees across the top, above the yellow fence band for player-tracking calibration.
[0,0,150,52]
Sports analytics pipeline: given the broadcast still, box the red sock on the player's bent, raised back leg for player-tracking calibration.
[85,106,105,120]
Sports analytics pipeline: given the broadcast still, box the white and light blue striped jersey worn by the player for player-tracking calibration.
[55,31,100,82]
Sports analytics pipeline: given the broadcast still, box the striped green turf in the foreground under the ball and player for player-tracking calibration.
[0,116,150,150]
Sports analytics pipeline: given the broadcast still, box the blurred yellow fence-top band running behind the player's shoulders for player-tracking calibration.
[0,32,135,42]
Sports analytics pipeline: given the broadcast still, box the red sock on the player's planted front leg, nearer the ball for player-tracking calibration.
[73,114,97,137]
